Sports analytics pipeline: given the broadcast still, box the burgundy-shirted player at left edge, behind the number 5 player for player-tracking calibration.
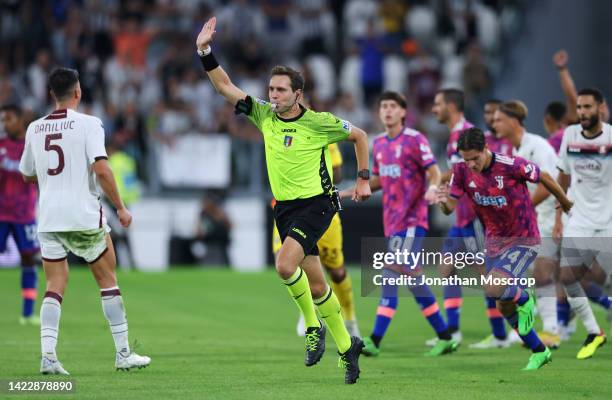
[0,104,39,325]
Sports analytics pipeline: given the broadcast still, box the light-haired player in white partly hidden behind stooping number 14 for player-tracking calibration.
[493,100,561,348]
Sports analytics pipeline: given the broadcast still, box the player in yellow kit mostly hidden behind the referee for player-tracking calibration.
[272,143,361,337]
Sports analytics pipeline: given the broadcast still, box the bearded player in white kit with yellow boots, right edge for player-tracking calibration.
[554,89,612,359]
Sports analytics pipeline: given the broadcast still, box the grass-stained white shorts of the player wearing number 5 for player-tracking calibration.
[38,225,110,264]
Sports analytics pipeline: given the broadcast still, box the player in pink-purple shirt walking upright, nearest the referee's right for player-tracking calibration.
[343,92,457,356]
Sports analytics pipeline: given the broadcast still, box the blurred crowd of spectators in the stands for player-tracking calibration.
[0,0,525,190]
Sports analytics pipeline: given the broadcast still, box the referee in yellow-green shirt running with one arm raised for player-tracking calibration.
[196,17,371,384]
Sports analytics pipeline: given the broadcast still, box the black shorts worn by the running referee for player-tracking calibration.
[274,194,336,256]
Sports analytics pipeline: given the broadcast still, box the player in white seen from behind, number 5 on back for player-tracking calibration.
[19,68,151,375]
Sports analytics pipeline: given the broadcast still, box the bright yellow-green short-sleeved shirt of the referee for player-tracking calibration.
[248,97,351,201]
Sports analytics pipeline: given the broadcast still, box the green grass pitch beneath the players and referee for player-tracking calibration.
[0,268,612,400]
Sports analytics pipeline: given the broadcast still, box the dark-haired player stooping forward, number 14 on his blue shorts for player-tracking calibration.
[438,128,572,370]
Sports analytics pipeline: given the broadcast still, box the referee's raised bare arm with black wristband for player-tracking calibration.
[196,17,246,105]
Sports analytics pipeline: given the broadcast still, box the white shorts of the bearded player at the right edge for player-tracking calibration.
[561,224,612,273]
